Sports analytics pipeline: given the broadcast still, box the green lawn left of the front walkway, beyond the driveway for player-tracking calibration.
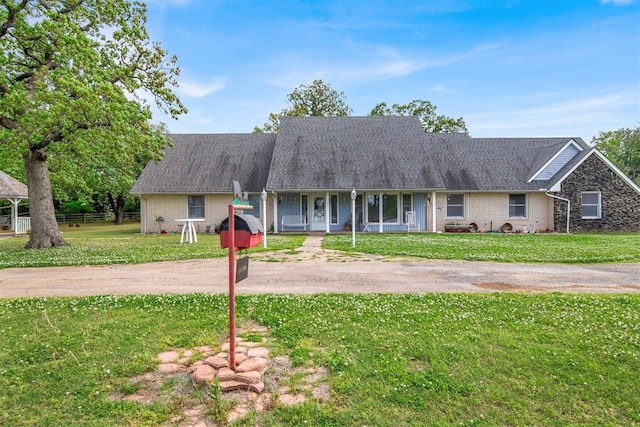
[0,223,305,269]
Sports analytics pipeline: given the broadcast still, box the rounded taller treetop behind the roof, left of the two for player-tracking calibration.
[253,80,351,133]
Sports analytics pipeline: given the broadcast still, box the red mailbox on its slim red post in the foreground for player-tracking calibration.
[219,204,262,371]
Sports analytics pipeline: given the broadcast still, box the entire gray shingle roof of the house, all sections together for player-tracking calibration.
[131,116,591,194]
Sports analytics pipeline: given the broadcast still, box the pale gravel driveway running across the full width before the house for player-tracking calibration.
[0,236,640,297]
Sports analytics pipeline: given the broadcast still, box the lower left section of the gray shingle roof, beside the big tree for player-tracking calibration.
[131,134,276,194]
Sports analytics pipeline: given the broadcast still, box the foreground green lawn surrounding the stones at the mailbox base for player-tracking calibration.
[0,293,640,426]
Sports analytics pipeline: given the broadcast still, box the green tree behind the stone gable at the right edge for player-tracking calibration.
[592,126,640,185]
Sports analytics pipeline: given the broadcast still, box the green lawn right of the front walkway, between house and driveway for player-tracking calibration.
[323,233,640,264]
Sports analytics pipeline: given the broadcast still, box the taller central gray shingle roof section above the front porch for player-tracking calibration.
[267,117,467,190]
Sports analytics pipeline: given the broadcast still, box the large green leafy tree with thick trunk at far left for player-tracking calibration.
[0,0,186,248]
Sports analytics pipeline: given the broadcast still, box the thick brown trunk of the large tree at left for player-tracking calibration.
[25,149,67,249]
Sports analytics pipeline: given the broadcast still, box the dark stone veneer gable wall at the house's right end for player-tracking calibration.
[553,154,640,232]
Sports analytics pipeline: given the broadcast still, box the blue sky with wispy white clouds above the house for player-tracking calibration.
[147,0,640,142]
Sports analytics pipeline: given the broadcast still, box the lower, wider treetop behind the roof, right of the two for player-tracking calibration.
[369,99,468,133]
